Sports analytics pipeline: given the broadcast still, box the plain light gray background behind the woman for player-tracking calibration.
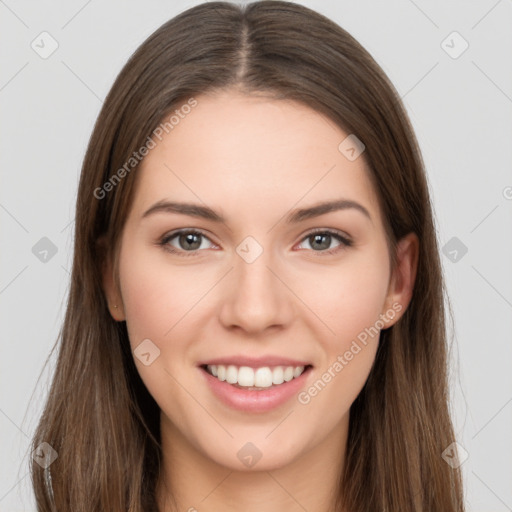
[0,0,512,512]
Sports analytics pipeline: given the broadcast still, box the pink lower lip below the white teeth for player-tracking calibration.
[199,366,312,412]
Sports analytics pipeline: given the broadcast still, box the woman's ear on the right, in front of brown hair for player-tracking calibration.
[381,233,420,329]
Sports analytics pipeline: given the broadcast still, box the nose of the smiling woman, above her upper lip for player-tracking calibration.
[220,245,294,335]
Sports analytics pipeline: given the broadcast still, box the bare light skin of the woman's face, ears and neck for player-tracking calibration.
[104,91,418,512]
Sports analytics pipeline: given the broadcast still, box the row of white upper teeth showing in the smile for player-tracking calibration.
[206,364,304,388]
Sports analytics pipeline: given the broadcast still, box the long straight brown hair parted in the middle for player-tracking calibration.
[31,1,464,512]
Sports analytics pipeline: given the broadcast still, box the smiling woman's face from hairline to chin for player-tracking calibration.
[101,92,416,470]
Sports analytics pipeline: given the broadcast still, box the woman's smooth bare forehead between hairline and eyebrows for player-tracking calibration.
[132,91,379,228]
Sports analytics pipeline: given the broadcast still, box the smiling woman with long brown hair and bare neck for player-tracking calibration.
[32,1,464,512]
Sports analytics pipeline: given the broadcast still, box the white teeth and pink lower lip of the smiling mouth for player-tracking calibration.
[198,364,313,413]
